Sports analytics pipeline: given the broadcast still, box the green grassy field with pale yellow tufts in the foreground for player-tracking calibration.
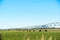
[0,31,60,40]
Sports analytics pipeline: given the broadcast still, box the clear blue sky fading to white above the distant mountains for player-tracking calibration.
[0,0,60,29]
